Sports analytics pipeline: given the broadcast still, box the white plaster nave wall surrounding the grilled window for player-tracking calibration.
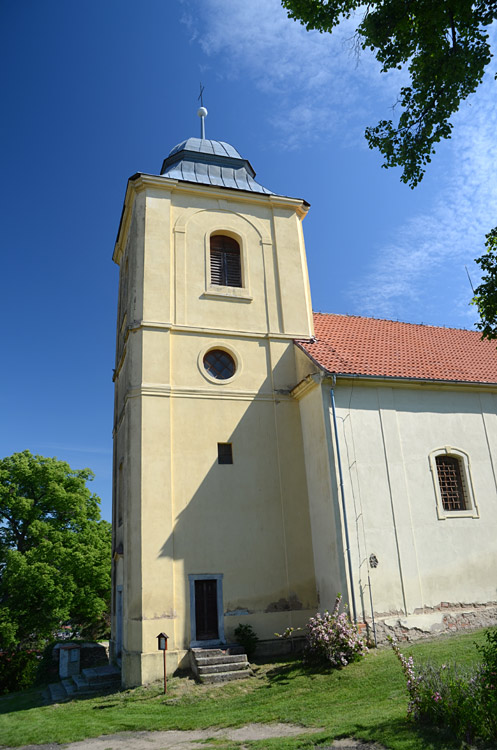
[330,380,497,614]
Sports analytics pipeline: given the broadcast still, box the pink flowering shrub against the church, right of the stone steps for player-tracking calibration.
[305,594,368,668]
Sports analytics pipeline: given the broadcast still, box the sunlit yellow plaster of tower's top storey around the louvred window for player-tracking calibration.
[136,185,312,338]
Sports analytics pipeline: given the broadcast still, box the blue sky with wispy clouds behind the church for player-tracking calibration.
[0,0,497,519]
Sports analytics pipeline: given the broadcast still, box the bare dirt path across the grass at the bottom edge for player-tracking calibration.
[4,724,384,750]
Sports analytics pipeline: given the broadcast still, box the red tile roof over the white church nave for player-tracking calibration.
[297,313,497,384]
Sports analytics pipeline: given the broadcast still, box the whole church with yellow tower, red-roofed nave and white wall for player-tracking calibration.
[111,108,497,686]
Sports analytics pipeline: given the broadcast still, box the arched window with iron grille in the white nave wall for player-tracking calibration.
[430,446,479,519]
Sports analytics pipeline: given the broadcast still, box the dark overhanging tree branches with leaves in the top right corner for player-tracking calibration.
[282,0,497,187]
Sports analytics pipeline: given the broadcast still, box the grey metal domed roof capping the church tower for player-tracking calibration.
[161,138,272,194]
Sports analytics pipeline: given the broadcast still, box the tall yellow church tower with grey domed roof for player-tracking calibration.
[112,108,317,686]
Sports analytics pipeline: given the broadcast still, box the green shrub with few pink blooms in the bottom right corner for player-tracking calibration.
[392,631,497,742]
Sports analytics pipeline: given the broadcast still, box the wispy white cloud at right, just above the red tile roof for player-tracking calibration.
[351,66,497,325]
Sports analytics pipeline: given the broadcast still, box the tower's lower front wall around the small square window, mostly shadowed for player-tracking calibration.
[160,356,330,642]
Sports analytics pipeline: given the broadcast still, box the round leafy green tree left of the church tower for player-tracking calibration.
[0,451,111,647]
